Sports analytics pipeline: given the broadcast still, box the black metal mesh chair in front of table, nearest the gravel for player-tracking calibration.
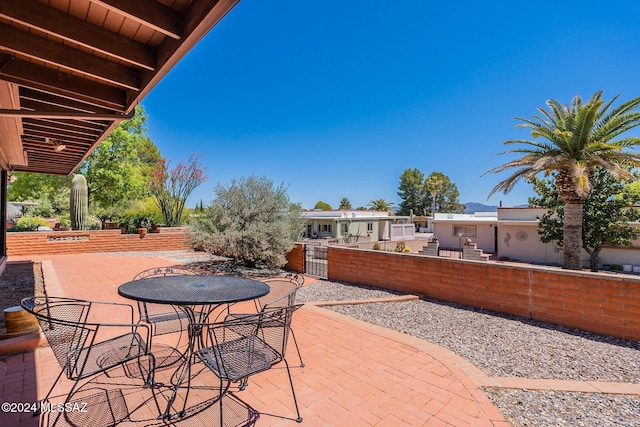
[185,305,302,422]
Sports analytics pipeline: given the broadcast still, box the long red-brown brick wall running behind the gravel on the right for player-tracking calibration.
[328,246,640,340]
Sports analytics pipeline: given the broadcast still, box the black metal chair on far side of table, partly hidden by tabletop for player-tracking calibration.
[133,267,198,341]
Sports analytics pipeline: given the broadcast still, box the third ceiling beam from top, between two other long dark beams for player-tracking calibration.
[0,24,140,90]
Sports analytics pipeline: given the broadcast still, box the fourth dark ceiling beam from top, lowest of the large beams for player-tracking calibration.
[0,54,127,113]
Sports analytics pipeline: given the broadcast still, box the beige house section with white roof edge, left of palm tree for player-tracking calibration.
[431,212,498,253]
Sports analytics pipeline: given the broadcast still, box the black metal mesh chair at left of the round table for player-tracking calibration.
[20,296,159,424]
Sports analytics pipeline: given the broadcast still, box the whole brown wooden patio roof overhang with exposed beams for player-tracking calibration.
[0,0,239,175]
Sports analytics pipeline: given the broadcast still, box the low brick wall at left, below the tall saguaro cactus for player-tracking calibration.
[7,227,190,256]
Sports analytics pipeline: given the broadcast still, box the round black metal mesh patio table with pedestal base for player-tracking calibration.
[118,275,270,418]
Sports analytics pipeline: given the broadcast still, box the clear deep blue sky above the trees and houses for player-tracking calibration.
[143,0,640,208]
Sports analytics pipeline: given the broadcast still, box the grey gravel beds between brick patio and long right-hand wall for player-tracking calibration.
[296,281,640,427]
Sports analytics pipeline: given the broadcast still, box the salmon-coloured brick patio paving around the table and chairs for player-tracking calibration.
[0,254,640,426]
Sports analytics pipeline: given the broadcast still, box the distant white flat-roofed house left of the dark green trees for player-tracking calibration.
[302,210,414,243]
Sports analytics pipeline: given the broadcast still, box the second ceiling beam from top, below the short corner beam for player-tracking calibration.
[0,0,156,70]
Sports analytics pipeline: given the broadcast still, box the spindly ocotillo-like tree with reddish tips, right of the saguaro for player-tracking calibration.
[149,153,207,227]
